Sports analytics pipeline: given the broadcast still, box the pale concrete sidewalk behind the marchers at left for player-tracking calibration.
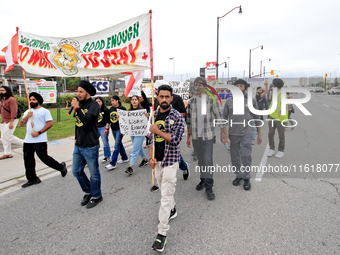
[0,132,132,193]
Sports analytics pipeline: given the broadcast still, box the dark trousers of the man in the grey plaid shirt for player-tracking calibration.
[192,138,214,189]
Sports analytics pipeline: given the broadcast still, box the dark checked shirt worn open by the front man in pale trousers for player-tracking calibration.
[149,107,185,167]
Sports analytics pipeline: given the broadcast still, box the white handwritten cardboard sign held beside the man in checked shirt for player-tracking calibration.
[117,109,148,136]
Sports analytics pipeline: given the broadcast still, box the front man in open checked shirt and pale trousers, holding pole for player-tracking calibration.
[149,85,185,252]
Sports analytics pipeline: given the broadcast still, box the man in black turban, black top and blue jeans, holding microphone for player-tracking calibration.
[71,81,103,209]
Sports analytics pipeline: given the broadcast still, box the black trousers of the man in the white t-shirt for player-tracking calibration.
[23,142,63,182]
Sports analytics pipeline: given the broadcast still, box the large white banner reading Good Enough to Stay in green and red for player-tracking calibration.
[18,13,151,77]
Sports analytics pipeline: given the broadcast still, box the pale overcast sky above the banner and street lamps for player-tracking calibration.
[0,0,340,81]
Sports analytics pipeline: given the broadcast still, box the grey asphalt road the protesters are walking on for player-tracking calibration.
[0,94,340,254]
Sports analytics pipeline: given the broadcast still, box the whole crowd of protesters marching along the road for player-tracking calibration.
[0,77,293,252]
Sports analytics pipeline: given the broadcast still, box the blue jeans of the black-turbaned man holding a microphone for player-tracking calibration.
[72,145,102,198]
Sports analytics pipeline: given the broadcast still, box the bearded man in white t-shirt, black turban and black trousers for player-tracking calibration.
[19,92,67,188]
